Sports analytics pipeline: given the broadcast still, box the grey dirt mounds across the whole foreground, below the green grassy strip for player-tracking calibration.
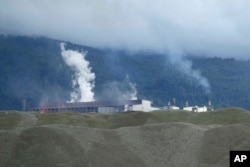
[0,123,250,167]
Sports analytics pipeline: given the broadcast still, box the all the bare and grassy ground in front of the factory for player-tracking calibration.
[0,108,250,167]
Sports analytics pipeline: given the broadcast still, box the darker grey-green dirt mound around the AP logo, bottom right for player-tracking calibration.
[198,124,250,167]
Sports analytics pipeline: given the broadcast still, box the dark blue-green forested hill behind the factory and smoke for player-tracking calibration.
[0,36,250,109]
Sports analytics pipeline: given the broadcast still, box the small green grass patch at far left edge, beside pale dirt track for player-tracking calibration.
[0,111,22,130]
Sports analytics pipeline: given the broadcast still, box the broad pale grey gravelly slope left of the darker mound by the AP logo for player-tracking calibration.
[117,123,205,167]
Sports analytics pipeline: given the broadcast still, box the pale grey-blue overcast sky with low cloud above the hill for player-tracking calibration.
[0,0,250,59]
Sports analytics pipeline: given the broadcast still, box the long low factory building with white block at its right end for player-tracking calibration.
[32,99,157,113]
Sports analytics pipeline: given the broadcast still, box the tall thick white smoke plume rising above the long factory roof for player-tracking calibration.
[60,43,95,102]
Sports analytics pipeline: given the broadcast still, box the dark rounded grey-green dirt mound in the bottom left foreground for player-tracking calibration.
[7,127,88,167]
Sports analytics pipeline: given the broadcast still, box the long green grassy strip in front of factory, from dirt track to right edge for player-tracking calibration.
[35,108,250,129]
